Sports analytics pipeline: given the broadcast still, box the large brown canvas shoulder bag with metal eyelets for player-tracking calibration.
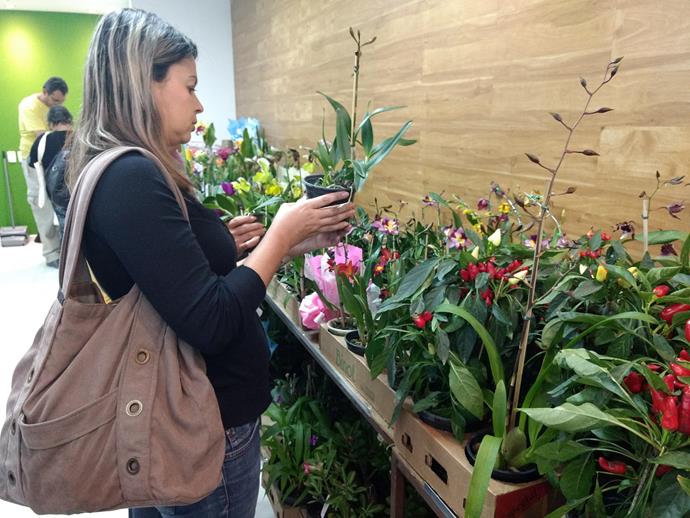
[0,147,225,514]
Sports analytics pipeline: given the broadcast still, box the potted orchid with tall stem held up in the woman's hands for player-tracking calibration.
[304,28,415,203]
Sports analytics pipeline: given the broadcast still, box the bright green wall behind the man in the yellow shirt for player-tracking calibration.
[0,10,98,233]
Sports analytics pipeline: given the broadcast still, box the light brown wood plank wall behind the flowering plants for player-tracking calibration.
[232,0,690,244]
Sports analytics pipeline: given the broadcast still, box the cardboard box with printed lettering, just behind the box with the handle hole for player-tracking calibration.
[319,325,395,439]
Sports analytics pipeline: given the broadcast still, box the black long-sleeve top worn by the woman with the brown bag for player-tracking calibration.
[84,153,270,428]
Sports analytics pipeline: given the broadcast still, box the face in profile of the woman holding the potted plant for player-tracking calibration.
[153,58,204,152]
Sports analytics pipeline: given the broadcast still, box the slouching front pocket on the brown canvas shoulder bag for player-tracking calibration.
[19,390,117,450]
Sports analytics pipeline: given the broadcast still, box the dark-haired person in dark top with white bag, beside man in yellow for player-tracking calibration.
[29,105,72,243]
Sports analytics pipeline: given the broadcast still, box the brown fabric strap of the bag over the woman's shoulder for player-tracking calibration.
[58,146,189,303]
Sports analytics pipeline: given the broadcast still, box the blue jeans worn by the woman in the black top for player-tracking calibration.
[129,421,261,518]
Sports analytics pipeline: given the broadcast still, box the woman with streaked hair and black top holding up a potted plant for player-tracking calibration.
[67,9,354,518]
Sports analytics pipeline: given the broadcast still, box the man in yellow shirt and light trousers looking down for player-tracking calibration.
[18,77,67,267]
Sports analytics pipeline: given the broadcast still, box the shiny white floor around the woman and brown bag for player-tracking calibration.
[0,239,273,518]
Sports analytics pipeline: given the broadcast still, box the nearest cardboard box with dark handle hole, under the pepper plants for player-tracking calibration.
[395,409,557,518]
